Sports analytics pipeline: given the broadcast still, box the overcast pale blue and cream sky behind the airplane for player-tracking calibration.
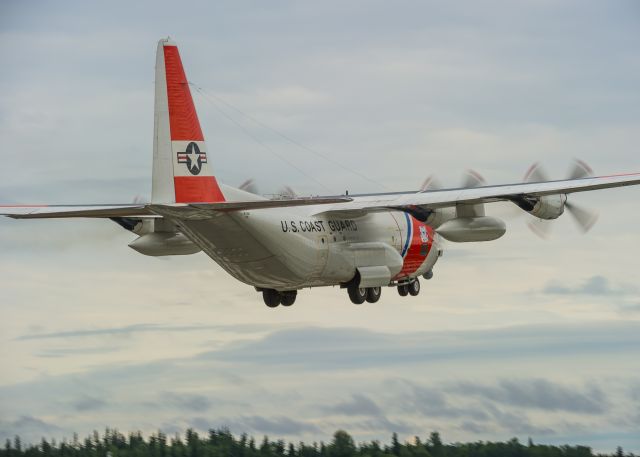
[0,0,640,452]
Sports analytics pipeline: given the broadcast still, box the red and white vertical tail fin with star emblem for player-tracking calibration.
[151,39,224,203]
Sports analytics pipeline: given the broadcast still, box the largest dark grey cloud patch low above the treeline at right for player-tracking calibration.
[450,379,610,414]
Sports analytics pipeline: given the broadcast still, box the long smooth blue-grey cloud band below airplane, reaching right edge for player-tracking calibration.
[200,321,640,370]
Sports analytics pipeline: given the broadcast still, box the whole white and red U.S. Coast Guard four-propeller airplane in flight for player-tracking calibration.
[0,38,640,308]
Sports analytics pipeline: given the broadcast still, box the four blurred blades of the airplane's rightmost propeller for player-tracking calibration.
[524,159,598,239]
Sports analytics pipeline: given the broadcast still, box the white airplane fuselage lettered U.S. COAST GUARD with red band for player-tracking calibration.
[172,201,440,290]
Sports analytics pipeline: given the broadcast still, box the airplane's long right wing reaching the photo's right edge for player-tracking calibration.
[316,173,640,214]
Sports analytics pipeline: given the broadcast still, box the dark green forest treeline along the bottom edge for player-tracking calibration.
[0,429,636,457]
